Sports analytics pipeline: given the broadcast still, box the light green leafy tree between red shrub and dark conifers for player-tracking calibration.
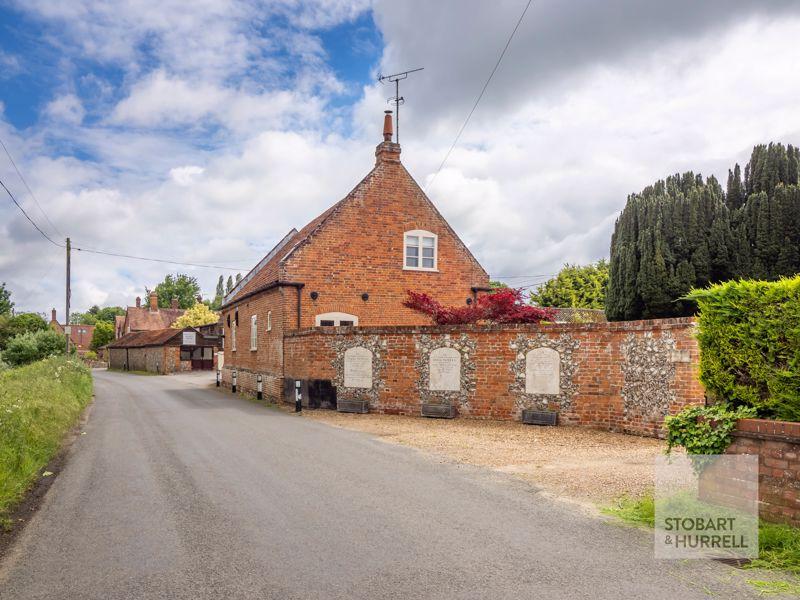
[531,260,608,308]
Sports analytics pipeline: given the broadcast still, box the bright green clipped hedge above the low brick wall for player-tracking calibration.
[688,276,800,421]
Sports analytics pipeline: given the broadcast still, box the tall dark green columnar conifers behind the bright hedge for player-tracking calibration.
[606,144,800,320]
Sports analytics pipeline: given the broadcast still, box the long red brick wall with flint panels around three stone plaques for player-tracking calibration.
[278,319,704,436]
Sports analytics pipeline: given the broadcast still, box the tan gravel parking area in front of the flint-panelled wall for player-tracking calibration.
[303,410,664,506]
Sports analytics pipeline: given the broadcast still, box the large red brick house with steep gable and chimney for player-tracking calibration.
[222,114,489,398]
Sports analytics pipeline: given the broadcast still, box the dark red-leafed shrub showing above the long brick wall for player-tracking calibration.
[403,288,555,325]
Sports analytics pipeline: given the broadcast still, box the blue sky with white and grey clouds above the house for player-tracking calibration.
[0,0,800,312]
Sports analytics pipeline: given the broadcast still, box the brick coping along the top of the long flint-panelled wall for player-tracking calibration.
[284,317,696,337]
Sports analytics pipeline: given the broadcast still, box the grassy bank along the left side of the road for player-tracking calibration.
[0,357,92,529]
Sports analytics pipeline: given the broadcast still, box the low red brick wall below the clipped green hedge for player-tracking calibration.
[727,419,800,526]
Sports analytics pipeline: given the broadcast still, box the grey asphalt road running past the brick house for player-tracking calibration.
[0,371,750,600]
